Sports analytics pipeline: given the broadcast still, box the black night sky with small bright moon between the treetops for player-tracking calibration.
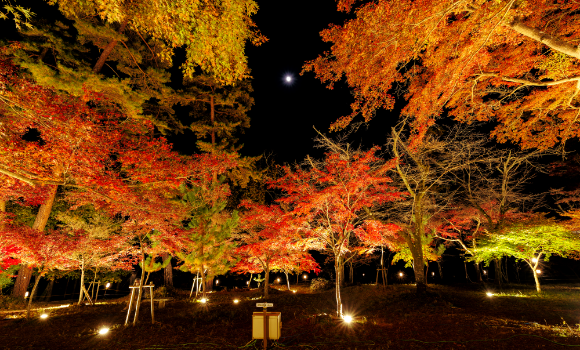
[241,0,396,163]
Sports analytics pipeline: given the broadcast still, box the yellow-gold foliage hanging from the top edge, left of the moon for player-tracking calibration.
[45,0,265,84]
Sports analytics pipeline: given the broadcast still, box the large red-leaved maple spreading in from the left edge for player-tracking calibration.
[0,55,202,296]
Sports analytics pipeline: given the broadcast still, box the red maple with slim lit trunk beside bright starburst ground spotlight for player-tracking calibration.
[271,139,401,316]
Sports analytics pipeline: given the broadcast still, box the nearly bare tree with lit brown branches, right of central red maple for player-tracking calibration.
[384,123,490,293]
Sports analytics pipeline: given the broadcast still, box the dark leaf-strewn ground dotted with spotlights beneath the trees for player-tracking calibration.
[0,284,580,350]
